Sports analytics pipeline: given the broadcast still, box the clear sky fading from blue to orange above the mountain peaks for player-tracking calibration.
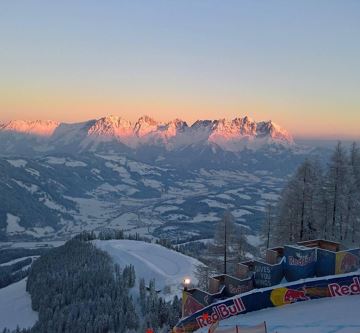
[0,0,360,139]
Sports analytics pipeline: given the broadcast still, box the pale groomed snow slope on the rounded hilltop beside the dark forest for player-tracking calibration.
[94,240,201,298]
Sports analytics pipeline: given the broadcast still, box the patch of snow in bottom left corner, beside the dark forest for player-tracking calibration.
[0,278,38,331]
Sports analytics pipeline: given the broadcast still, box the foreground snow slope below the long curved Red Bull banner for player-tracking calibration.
[196,295,360,333]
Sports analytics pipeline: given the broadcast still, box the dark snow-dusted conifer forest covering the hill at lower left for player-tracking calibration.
[3,237,181,333]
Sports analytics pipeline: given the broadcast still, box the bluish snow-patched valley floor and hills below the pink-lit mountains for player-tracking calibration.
[0,148,284,242]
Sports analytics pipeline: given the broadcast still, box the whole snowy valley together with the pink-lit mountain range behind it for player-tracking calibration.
[0,116,326,246]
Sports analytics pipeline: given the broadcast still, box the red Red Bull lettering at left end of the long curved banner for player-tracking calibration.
[196,297,246,327]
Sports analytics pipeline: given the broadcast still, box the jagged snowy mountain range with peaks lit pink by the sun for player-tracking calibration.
[0,116,294,152]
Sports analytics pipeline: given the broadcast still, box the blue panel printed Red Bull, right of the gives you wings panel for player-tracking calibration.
[284,245,316,282]
